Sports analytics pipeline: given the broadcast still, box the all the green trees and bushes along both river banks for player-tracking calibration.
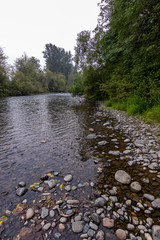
[0,0,160,122]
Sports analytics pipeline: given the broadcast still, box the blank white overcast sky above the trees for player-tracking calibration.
[0,0,100,65]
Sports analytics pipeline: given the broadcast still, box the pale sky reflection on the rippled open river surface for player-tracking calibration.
[0,94,97,212]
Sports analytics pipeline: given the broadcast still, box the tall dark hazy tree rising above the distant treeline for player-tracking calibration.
[43,43,72,80]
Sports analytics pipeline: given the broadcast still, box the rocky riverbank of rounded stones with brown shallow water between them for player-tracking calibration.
[0,109,160,240]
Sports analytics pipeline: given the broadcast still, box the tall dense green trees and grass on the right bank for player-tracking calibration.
[71,0,160,122]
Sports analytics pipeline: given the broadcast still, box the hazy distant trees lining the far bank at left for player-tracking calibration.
[0,44,73,97]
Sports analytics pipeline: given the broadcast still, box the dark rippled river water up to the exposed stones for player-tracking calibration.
[0,94,159,239]
